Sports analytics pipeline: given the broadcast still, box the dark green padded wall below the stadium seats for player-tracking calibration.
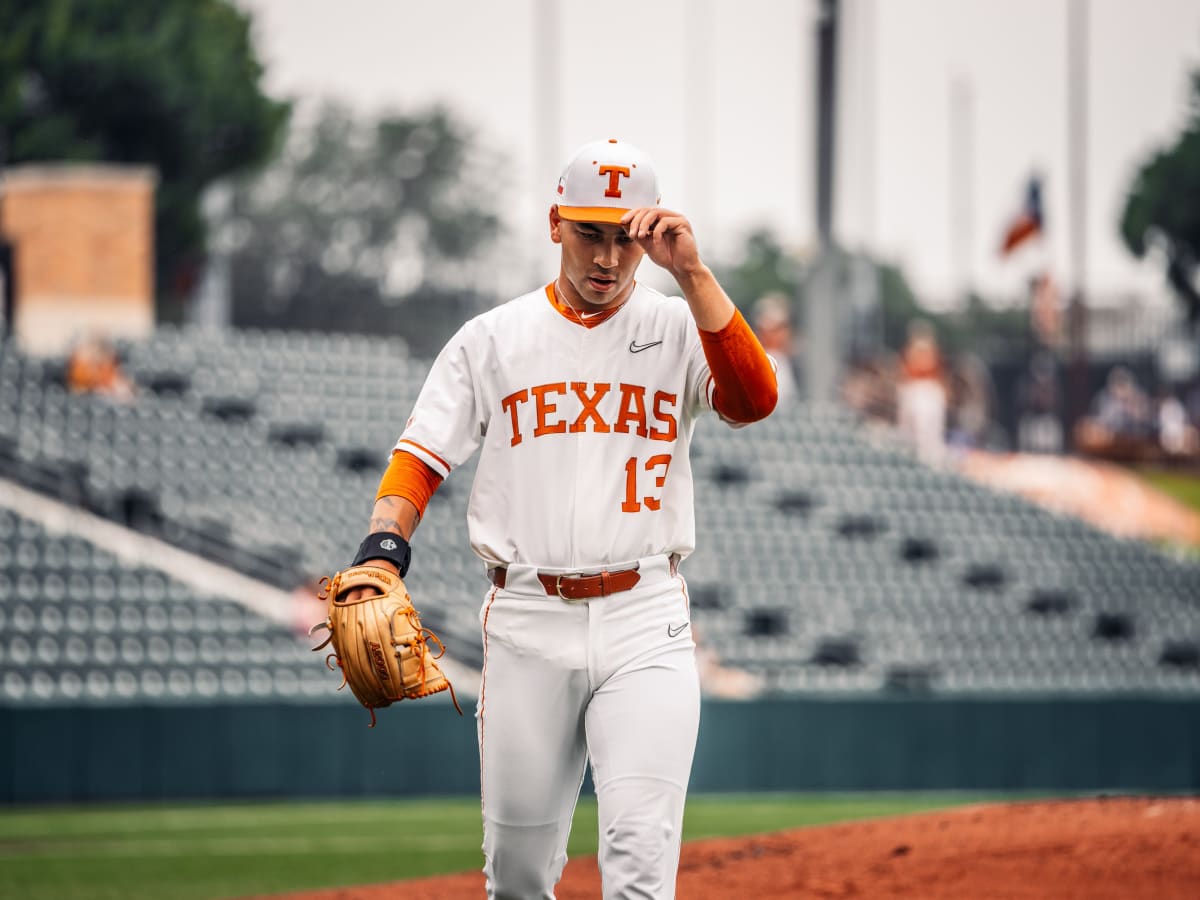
[0,697,1200,804]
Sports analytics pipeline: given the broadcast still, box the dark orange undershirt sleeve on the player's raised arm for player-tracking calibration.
[700,311,779,424]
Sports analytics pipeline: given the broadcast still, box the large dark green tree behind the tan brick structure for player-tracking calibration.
[0,0,288,318]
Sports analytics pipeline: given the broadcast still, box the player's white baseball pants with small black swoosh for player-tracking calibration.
[476,557,700,900]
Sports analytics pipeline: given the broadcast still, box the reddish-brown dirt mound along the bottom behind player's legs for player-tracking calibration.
[270,797,1200,900]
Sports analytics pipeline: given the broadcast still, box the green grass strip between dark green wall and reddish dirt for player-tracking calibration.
[0,794,998,900]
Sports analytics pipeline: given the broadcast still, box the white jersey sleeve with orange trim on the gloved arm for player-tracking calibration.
[395,323,484,478]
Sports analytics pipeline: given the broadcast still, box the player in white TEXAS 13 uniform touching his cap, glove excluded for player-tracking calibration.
[355,140,776,900]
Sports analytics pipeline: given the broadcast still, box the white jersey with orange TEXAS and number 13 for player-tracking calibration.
[396,284,713,571]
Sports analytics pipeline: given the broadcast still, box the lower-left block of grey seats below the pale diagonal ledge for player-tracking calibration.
[0,510,336,703]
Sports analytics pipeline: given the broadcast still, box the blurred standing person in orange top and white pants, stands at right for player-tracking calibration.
[896,319,946,466]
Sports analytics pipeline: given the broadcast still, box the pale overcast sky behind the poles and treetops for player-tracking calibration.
[236,0,1200,305]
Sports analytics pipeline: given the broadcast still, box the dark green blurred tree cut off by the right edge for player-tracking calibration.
[1121,72,1200,328]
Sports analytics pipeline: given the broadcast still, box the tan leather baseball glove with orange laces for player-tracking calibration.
[308,565,462,728]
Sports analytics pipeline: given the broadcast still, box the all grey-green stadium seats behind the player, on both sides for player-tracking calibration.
[0,329,1200,703]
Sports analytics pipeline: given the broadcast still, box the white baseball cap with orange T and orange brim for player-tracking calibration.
[556,138,662,224]
